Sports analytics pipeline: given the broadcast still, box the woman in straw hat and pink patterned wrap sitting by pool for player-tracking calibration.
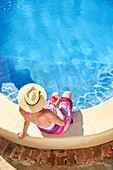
[17,83,72,139]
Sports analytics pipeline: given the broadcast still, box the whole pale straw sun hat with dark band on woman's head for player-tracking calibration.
[18,83,47,113]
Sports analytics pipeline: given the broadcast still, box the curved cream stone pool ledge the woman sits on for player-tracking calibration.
[0,93,113,149]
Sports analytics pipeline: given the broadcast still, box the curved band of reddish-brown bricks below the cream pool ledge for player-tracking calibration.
[0,137,113,167]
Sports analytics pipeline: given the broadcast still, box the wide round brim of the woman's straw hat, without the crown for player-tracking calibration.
[18,83,47,113]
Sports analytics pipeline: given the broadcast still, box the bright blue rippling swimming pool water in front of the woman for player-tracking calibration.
[0,0,113,110]
